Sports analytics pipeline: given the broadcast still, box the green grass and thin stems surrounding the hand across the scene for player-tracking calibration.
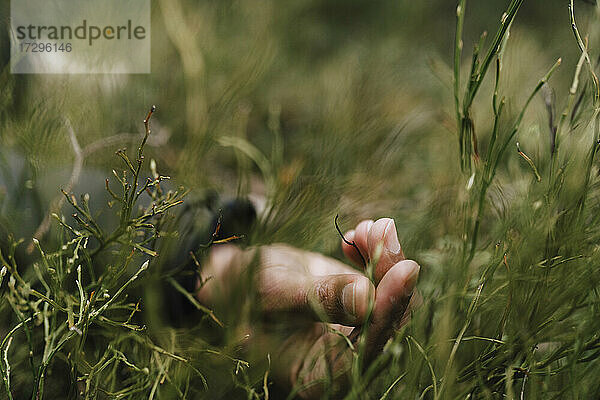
[0,0,600,399]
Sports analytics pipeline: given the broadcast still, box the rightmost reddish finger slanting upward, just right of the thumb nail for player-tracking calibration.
[358,260,420,358]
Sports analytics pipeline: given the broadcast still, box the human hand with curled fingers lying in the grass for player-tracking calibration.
[198,218,419,398]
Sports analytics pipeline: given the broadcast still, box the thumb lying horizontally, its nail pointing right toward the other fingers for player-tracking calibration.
[259,267,375,326]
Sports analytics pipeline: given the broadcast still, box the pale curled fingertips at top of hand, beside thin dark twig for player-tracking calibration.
[342,218,404,284]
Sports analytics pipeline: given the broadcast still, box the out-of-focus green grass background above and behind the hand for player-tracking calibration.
[1,1,596,250]
